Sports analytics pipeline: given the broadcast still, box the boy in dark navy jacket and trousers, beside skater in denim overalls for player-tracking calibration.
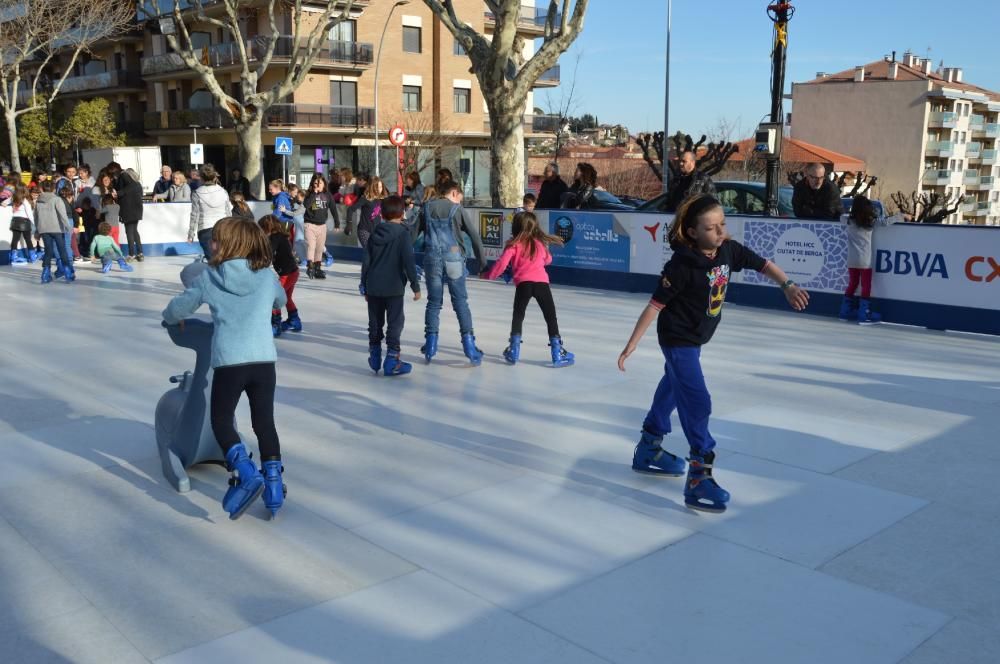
[361,196,420,376]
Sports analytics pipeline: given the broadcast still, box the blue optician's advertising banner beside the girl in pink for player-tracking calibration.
[549,210,631,272]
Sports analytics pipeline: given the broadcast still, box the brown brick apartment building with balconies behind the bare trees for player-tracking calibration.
[39,0,559,199]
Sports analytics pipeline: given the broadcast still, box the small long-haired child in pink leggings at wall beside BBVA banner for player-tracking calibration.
[840,195,906,325]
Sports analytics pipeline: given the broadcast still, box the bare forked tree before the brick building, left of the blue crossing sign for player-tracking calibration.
[143,0,354,197]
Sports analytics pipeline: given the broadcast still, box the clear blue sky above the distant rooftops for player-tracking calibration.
[535,0,1000,135]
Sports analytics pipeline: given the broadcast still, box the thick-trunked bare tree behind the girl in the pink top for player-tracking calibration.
[424,0,589,207]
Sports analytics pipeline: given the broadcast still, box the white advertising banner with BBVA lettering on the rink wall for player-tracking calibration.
[872,224,1000,309]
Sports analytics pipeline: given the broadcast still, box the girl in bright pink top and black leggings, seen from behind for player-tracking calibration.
[483,212,574,368]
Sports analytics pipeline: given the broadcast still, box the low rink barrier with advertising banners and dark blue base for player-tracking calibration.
[0,203,1000,334]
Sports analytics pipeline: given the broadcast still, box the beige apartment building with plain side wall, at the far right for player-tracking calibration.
[791,53,1000,226]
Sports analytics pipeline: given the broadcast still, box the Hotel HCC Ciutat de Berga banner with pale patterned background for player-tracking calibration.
[741,219,847,293]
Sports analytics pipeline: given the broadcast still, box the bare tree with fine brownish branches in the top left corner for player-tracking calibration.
[0,0,135,170]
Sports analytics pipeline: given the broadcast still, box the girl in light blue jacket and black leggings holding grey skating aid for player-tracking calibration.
[163,217,285,519]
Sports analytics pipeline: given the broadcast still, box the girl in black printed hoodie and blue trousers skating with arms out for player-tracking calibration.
[618,194,809,512]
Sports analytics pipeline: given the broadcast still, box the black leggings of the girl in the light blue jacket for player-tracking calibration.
[212,362,281,461]
